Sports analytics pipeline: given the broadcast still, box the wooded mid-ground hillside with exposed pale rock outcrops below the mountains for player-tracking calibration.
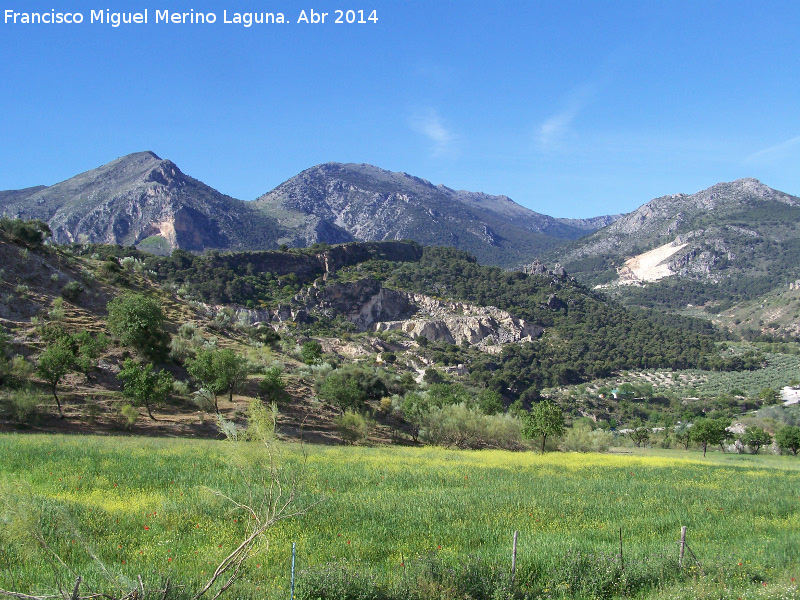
[0,217,759,440]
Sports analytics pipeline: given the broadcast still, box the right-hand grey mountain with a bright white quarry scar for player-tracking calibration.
[549,179,800,310]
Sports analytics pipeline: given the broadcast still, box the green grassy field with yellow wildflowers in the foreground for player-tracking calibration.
[0,435,800,598]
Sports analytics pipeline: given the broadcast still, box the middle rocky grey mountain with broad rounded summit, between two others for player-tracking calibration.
[254,163,616,266]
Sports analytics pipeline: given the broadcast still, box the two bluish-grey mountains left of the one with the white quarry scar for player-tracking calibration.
[0,152,619,266]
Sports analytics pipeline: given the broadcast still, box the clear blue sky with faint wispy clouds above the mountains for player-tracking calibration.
[0,0,800,217]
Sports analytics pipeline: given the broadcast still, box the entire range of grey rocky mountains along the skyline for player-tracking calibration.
[0,152,800,309]
